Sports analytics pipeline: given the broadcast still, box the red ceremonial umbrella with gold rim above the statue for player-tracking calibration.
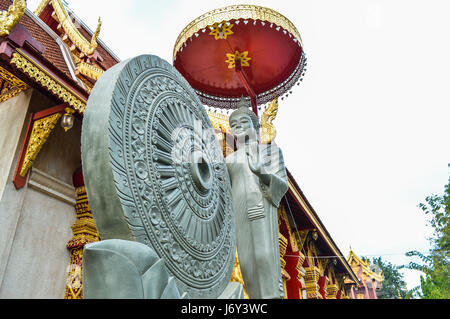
[173,5,306,114]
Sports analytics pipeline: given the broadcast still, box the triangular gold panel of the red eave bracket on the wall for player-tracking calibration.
[20,113,61,177]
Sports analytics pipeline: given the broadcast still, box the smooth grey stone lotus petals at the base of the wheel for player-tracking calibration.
[83,239,182,299]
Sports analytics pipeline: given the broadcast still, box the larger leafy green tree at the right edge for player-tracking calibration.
[406,164,450,299]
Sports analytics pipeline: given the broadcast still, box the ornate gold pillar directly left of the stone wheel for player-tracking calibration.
[64,168,99,299]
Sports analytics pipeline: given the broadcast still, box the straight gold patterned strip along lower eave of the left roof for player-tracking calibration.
[11,51,86,113]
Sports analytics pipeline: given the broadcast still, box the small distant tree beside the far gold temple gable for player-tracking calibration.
[372,257,407,299]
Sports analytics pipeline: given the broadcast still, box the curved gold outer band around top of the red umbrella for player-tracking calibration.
[173,4,303,59]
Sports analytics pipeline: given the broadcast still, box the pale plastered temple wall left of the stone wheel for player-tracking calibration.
[0,90,81,299]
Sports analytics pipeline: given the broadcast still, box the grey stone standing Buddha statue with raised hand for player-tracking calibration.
[226,105,288,299]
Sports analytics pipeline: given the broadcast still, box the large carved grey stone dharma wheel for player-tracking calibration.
[81,55,235,298]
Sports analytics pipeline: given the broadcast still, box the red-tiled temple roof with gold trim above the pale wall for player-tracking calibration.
[0,0,120,113]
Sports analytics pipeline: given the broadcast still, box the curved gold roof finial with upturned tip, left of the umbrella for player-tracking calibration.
[51,0,102,55]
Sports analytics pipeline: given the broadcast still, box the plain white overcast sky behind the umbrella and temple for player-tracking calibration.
[28,0,450,288]
